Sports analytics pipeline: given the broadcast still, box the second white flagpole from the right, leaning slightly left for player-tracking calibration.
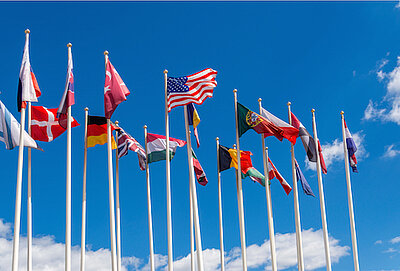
[311,109,332,271]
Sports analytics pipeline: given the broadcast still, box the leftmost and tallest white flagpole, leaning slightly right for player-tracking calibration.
[12,29,30,271]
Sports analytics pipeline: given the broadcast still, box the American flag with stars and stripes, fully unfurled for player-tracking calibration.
[167,68,217,112]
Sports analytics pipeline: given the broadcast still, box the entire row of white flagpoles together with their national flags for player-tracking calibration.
[0,30,359,271]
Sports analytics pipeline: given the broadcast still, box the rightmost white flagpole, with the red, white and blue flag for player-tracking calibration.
[340,111,360,271]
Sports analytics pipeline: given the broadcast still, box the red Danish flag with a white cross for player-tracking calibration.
[31,106,79,142]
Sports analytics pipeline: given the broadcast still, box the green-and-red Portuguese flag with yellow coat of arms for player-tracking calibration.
[237,103,284,140]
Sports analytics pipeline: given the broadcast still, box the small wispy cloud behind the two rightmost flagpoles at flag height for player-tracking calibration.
[305,131,369,171]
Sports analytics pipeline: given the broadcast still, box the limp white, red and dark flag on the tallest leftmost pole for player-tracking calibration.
[17,33,41,112]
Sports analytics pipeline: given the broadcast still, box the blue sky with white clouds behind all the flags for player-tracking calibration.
[0,2,400,271]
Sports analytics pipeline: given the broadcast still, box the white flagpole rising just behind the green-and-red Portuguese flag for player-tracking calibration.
[258,98,278,271]
